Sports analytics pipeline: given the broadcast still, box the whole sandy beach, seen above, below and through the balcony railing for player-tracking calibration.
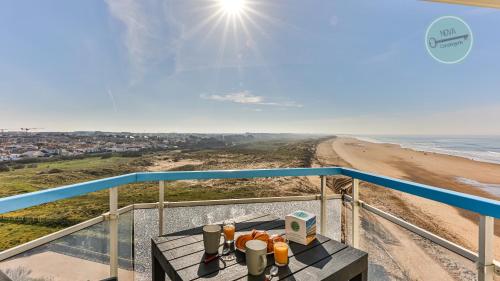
[316,137,500,280]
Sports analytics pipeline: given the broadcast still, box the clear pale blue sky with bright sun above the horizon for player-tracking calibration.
[0,0,500,135]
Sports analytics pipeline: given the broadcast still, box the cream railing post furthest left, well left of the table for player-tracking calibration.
[109,187,118,278]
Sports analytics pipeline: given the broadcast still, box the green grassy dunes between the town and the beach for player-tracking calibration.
[0,137,318,250]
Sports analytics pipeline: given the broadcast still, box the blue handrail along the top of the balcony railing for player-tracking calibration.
[0,167,500,218]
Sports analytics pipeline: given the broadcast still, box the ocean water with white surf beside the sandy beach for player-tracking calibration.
[355,135,500,196]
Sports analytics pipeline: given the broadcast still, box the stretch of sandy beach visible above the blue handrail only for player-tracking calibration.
[320,137,500,200]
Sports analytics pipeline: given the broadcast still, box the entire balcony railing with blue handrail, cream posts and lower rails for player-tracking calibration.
[0,167,500,281]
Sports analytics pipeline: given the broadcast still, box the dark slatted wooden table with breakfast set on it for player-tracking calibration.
[151,215,368,281]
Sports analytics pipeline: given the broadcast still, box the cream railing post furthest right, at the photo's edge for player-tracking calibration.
[477,215,495,281]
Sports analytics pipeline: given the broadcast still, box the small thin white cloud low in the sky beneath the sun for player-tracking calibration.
[200,91,303,108]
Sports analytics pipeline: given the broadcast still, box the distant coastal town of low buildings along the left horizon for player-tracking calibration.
[0,131,262,162]
